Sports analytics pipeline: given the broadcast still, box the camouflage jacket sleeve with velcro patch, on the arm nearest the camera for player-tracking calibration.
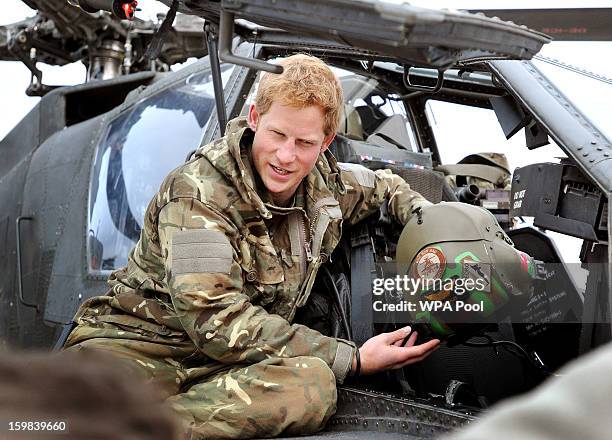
[158,198,355,383]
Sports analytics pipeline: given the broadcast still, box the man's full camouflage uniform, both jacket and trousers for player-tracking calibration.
[66,118,429,438]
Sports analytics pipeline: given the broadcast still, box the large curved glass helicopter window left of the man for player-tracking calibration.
[88,65,233,271]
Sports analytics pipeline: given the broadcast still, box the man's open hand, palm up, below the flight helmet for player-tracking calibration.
[351,327,440,375]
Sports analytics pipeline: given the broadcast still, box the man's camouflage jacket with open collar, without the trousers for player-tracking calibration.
[68,118,429,382]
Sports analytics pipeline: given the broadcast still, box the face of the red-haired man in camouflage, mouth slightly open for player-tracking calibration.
[249,101,335,205]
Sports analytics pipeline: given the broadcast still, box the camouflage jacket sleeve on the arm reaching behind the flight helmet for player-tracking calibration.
[338,163,431,229]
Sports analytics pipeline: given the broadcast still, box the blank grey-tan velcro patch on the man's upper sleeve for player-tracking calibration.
[172,229,233,275]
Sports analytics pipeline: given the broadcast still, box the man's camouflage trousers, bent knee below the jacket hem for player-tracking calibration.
[66,332,337,439]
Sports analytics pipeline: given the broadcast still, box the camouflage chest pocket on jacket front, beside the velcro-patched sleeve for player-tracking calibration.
[240,237,285,306]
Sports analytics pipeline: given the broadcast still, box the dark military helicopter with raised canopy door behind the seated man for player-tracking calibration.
[0,0,612,438]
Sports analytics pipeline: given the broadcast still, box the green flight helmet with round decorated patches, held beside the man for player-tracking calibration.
[396,202,536,339]
